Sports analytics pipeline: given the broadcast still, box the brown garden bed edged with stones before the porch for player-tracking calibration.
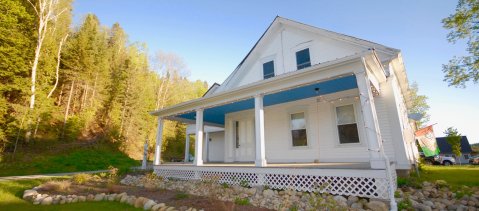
[39,183,270,211]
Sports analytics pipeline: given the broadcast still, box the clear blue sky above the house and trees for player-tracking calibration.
[73,0,479,143]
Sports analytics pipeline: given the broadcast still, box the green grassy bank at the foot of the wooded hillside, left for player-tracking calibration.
[0,144,140,177]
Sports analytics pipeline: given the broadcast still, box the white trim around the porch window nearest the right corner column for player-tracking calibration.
[331,100,364,148]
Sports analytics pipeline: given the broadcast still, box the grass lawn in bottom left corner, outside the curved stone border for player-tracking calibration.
[0,180,142,211]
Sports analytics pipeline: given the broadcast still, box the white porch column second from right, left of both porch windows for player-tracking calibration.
[254,95,266,167]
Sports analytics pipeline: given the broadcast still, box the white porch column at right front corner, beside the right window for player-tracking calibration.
[355,69,386,169]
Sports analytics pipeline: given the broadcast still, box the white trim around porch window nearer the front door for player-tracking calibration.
[286,105,312,150]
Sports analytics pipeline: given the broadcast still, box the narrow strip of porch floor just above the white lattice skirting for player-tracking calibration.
[161,162,371,169]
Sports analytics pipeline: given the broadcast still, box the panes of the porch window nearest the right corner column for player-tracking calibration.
[336,104,359,144]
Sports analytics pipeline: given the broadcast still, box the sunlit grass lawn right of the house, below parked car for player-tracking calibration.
[419,165,479,187]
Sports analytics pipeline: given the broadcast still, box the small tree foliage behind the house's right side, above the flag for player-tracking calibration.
[408,82,430,128]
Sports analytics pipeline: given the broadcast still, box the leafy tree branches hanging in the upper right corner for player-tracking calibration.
[442,0,479,88]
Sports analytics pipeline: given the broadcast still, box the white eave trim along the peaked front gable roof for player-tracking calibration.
[221,16,400,92]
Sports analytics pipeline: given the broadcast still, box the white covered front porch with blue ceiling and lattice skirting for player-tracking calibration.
[152,50,396,199]
